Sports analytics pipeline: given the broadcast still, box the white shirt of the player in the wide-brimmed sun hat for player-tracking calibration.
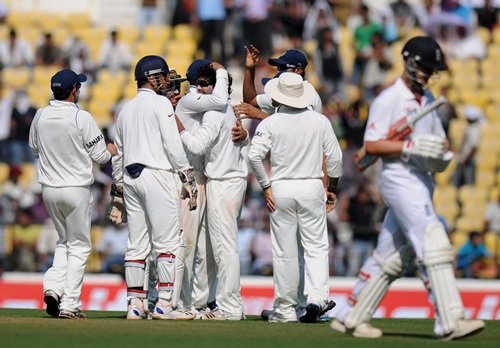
[248,106,342,187]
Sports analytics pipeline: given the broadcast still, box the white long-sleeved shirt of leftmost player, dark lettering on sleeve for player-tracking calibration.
[29,100,111,187]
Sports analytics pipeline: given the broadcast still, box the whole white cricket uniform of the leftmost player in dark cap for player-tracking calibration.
[29,100,111,312]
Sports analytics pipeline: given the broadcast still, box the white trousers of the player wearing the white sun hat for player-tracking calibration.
[270,180,329,320]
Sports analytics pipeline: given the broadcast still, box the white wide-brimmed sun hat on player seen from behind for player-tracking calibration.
[264,72,316,109]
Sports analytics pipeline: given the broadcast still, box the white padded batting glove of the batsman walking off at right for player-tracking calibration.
[401,135,446,162]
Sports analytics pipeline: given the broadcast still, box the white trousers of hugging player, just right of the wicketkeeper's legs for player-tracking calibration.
[180,171,216,308]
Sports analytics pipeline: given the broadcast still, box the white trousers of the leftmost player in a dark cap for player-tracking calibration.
[42,185,92,311]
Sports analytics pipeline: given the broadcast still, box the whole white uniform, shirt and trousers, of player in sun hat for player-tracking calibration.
[248,106,342,320]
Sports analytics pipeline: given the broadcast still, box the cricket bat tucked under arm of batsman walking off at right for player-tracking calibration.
[354,96,447,172]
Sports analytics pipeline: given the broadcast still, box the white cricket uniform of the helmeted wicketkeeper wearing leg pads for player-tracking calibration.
[112,88,190,299]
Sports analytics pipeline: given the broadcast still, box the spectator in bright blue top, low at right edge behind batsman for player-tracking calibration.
[457,231,496,278]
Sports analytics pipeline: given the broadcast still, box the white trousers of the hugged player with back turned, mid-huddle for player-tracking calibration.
[207,178,247,316]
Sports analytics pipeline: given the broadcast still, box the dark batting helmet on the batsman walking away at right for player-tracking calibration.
[401,36,448,70]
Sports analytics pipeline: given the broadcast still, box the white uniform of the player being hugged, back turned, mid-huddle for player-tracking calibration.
[181,105,248,317]
